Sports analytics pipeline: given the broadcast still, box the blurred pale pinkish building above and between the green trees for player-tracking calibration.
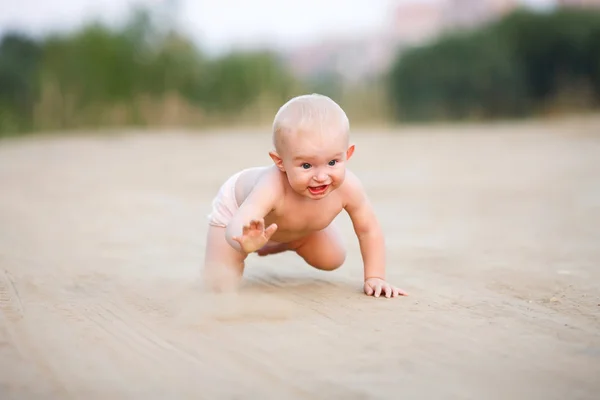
[286,0,524,82]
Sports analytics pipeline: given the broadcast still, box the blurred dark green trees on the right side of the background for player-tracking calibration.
[388,9,600,120]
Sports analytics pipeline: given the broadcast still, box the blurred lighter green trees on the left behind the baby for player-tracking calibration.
[0,5,297,135]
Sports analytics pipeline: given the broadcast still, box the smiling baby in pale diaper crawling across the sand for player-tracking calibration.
[205,94,406,298]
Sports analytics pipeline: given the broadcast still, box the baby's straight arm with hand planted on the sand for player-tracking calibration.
[344,171,406,297]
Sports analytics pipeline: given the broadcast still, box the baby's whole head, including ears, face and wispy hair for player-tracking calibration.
[269,94,354,199]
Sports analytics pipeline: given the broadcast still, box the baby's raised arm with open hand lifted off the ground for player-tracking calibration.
[225,172,282,253]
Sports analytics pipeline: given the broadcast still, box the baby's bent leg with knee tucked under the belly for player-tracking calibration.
[295,223,346,271]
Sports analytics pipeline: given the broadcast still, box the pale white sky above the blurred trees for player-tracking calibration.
[0,0,553,51]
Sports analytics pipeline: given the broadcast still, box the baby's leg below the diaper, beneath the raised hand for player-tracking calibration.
[204,225,247,290]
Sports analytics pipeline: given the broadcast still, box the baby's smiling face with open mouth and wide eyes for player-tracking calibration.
[282,128,351,199]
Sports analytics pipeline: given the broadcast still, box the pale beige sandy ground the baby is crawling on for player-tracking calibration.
[0,118,600,400]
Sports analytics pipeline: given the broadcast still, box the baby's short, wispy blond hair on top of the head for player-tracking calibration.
[273,93,350,152]
